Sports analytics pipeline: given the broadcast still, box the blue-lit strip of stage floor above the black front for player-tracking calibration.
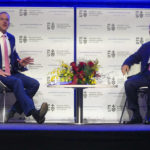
[0,123,150,132]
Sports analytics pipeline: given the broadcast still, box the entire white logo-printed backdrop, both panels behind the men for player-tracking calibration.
[0,7,150,123]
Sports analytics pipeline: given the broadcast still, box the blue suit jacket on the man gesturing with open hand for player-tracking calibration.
[0,32,27,73]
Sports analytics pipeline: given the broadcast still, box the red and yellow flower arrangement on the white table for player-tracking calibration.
[49,59,100,85]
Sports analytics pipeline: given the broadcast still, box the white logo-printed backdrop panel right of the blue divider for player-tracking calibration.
[77,8,150,123]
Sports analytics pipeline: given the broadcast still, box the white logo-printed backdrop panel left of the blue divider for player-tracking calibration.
[0,7,74,122]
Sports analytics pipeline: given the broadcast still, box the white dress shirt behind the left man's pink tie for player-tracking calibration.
[0,31,11,69]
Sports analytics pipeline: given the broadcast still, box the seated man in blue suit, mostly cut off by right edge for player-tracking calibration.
[122,39,150,124]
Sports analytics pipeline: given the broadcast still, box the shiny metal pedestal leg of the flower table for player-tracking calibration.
[75,88,83,124]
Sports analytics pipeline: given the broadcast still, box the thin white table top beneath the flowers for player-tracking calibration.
[47,84,116,88]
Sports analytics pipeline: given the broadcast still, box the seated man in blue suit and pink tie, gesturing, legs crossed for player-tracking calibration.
[0,12,48,124]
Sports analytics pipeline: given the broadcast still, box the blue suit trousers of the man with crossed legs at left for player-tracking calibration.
[0,72,39,116]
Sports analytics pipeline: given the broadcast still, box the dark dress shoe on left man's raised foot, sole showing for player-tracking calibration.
[31,103,48,124]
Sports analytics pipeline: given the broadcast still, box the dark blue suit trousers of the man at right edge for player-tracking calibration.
[125,73,150,110]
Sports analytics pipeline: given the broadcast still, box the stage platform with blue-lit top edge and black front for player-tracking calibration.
[0,123,150,150]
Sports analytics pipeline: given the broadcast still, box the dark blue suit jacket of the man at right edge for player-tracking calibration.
[123,42,150,73]
